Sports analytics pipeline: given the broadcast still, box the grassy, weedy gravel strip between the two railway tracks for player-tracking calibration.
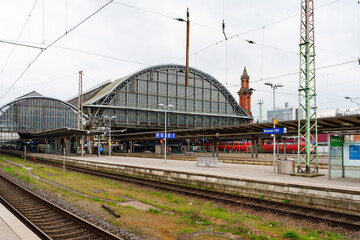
[0,157,345,240]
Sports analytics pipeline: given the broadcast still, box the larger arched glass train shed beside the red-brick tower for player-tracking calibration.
[84,65,252,129]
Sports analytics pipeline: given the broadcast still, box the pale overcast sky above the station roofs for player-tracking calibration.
[0,0,360,119]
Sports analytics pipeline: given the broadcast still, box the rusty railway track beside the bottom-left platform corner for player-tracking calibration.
[0,175,122,240]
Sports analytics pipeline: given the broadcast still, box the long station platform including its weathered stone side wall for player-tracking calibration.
[19,153,360,215]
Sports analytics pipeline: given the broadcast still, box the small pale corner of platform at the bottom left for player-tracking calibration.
[0,204,40,240]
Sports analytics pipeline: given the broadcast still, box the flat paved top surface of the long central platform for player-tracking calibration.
[37,154,360,192]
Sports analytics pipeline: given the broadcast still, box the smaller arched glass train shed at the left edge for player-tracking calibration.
[0,96,82,139]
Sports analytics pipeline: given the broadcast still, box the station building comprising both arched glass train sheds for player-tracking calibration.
[0,64,252,149]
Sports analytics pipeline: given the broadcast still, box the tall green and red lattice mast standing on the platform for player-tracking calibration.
[298,0,318,173]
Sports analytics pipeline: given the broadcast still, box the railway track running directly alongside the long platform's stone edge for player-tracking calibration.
[20,156,360,230]
